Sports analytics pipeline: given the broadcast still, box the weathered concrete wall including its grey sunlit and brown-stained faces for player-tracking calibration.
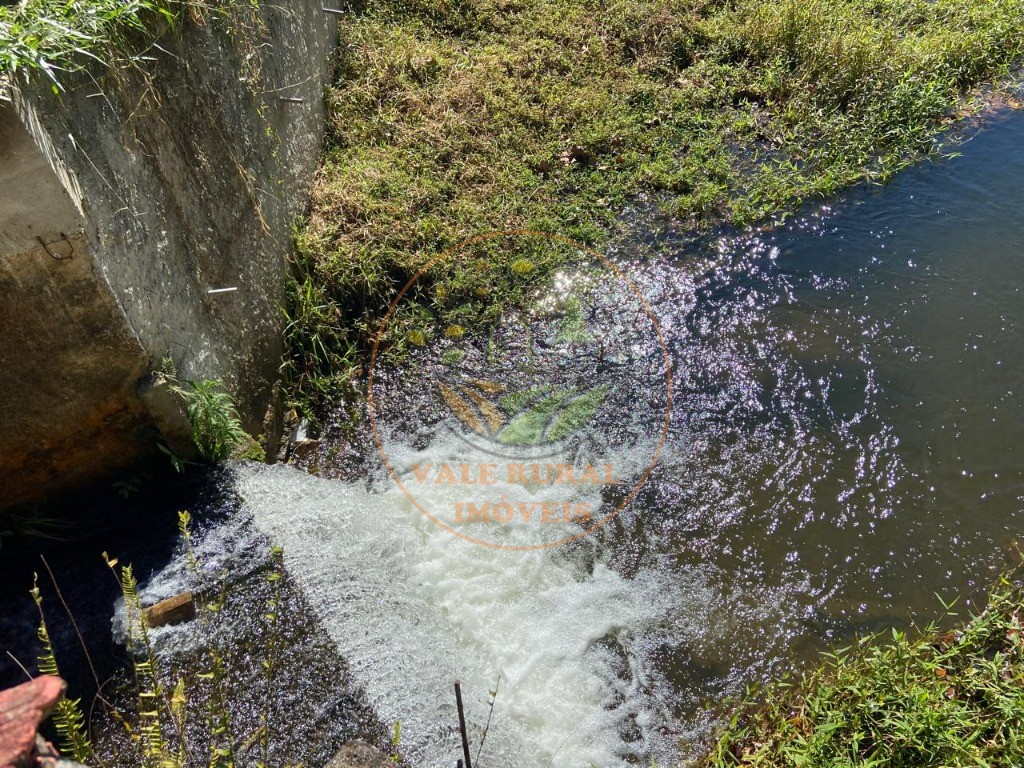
[0,6,335,508]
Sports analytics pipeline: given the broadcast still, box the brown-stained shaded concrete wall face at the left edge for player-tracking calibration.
[0,102,155,502]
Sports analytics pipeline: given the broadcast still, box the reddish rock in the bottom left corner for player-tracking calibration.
[0,675,68,768]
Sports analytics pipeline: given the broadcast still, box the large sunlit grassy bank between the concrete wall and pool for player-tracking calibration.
[290,0,1024,415]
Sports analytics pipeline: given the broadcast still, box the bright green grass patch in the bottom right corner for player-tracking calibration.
[700,578,1024,768]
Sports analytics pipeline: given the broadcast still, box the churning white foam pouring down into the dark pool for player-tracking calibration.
[234,443,665,768]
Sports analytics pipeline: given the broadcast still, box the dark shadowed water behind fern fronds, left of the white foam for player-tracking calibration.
[0,469,387,766]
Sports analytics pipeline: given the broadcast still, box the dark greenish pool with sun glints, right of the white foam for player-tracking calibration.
[623,107,1024,745]
